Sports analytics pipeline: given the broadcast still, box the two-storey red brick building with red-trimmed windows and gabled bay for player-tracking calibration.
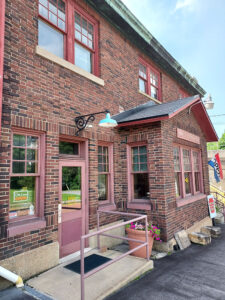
[0,0,217,284]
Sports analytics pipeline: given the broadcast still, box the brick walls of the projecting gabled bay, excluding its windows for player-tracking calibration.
[115,110,209,241]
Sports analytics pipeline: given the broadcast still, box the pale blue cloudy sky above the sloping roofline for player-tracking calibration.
[122,0,225,138]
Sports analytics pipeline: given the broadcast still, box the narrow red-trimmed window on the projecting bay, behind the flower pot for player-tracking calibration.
[130,145,149,201]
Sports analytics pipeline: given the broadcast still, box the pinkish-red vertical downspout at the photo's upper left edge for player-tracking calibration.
[0,0,5,136]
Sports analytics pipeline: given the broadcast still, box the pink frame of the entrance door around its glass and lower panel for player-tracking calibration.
[59,160,87,257]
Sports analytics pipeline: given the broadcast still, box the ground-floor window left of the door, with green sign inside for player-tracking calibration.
[9,132,44,219]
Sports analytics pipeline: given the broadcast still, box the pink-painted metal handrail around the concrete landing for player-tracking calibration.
[80,210,149,300]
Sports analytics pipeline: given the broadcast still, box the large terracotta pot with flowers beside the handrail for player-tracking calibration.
[126,223,160,258]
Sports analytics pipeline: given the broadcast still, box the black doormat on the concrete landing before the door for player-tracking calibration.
[64,254,111,274]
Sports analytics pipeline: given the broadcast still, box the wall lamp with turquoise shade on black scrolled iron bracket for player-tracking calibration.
[74,109,118,135]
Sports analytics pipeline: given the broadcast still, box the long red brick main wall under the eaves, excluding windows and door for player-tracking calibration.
[0,0,207,259]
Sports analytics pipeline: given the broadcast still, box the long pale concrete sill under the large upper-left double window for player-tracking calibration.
[36,46,105,86]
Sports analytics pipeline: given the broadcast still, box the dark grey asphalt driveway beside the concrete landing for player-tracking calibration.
[105,225,225,300]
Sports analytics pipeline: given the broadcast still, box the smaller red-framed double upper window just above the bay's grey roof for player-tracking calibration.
[139,61,161,100]
